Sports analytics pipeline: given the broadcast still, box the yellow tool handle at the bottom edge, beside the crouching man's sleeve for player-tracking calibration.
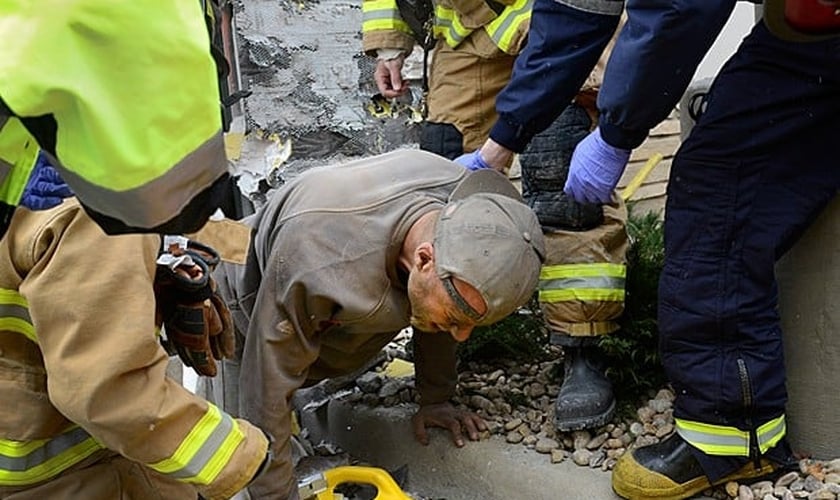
[298,465,412,500]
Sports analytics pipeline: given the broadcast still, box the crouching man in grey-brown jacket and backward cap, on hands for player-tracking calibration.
[202,150,544,500]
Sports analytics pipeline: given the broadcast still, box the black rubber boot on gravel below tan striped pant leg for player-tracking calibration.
[554,345,615,432]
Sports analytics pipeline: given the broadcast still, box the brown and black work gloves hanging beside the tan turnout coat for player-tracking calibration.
[155,236,235,377]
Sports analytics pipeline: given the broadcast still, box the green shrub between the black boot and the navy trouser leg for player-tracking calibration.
[599,207,666,403]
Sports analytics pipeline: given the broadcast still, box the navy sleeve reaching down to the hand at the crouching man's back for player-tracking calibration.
[490,0,623,152]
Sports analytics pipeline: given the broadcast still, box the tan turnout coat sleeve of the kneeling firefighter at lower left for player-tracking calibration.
[16,201,267,498]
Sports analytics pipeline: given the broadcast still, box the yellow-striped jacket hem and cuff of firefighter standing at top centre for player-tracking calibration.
[362,0,533,55]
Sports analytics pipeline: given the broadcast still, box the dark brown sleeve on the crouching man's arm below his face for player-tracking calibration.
[412,330,458,405]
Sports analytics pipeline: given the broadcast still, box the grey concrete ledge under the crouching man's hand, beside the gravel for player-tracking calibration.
[301,399,619,500]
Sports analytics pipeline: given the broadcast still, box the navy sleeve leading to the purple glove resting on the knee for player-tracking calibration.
[598,0,735,149]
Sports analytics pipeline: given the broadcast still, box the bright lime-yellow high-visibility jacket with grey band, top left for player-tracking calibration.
[0,0,229,236]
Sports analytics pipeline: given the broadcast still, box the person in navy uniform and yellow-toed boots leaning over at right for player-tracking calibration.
[460,0,840,499]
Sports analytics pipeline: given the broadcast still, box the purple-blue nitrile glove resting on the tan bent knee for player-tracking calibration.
[563,129,630,203]
